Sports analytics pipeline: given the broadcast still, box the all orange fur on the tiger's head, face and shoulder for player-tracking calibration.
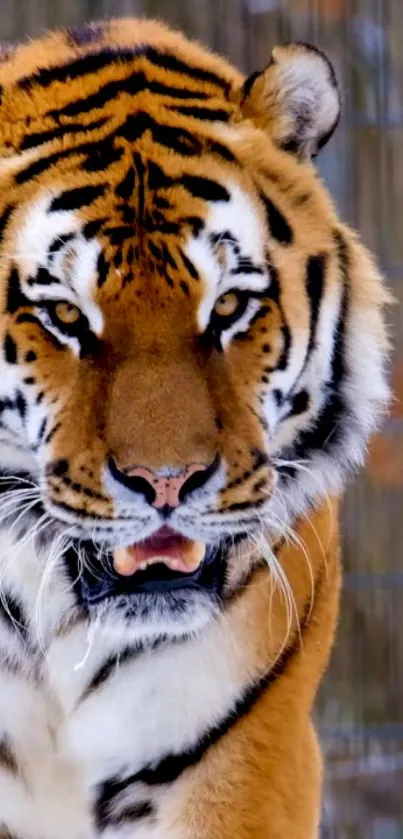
[0,20,387,839]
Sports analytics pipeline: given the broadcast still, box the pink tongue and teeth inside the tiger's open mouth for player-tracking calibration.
[113,527,206,577]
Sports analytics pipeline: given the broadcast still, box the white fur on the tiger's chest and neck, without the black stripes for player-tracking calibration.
[0,533,262,839]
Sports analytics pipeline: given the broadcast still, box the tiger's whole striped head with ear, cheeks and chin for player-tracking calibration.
[0,22,392,634]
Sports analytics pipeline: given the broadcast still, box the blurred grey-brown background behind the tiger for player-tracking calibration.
[0,0,403,839]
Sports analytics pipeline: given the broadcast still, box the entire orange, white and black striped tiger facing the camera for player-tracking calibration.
[0,18,390,839]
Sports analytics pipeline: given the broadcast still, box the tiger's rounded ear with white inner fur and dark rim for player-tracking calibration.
[240,43,340,158]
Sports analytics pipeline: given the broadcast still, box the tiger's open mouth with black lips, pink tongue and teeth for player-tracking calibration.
[73,527,229,606]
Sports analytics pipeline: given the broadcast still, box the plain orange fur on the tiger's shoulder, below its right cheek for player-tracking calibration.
[168,502,340,839]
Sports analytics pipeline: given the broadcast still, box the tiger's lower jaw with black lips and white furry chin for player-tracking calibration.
[66,538,230,644]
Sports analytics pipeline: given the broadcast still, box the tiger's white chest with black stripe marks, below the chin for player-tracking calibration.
[0,612,244,839]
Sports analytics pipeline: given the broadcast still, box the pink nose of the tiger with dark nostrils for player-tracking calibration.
[109,455,220,512]
